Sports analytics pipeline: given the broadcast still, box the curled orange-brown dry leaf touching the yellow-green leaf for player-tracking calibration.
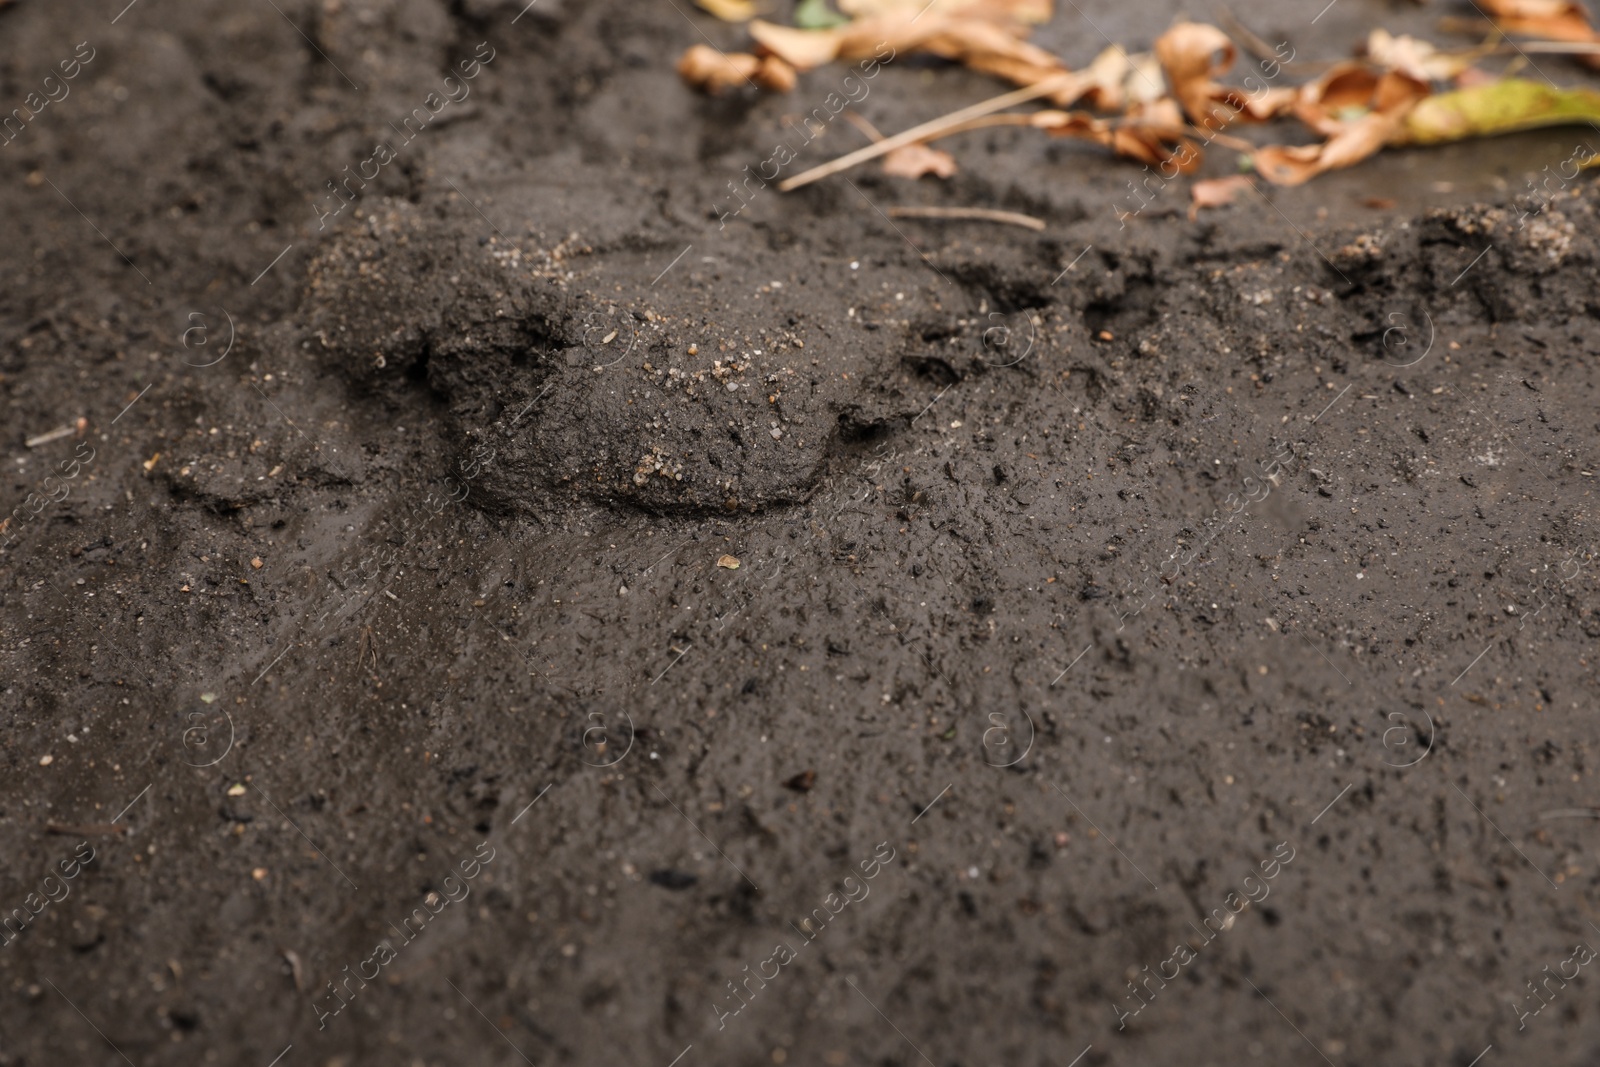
[1251,70,1430,186]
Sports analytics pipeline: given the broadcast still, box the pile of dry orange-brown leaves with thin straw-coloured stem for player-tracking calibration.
[678,0,1600,194]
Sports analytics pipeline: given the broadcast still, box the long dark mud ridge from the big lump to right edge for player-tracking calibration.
[290,186,1597,531]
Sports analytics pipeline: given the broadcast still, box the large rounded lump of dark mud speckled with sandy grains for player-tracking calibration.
[293,197,947,514]
